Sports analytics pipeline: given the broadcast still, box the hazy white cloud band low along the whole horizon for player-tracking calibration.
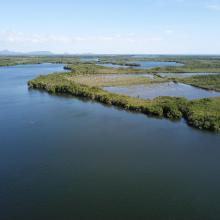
[0,28,220,54]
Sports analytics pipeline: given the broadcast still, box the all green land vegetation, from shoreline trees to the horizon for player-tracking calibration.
[0,56,220,131]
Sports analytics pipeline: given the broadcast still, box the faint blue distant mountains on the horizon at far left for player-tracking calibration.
[0,50,55,56]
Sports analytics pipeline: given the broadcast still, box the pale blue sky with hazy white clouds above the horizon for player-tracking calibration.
[0,0,220,54]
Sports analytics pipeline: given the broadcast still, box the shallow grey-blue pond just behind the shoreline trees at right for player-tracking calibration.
[104,82,220,99]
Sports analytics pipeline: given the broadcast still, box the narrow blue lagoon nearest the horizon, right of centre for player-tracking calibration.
[98,61,183,69]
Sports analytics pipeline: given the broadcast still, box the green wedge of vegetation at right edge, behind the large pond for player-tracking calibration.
[178,74,220,92]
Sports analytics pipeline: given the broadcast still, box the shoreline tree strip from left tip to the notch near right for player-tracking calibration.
[28,73,185,119]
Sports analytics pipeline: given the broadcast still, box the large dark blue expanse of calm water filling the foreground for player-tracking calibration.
[0,64,220,220]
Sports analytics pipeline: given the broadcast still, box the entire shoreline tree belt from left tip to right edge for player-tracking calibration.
[28,72,220,131]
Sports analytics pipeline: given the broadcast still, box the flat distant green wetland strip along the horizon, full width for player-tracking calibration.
[0,55,220,73]
